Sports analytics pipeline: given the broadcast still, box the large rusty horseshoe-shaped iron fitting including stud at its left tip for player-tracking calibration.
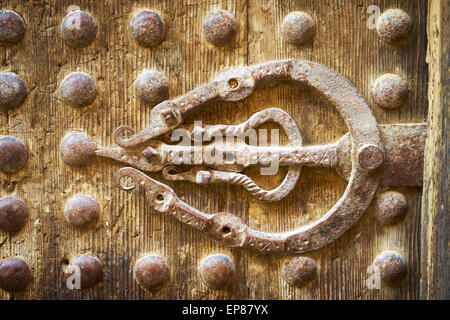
[60,60,427,253]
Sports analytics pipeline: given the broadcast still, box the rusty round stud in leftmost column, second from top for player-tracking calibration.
[0,72,28,111]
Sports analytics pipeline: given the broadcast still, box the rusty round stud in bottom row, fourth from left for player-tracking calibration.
[200,254,236,289]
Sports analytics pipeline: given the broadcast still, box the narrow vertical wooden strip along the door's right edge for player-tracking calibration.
[420,0,450,300]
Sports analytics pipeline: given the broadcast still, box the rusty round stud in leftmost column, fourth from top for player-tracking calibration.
[0,196,28,231]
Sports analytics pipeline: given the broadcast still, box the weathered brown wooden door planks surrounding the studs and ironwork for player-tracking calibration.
[0,0,427,299]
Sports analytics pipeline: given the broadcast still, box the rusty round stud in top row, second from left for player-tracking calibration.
[61,10,97,48]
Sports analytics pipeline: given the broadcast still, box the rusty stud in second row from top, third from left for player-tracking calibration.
[134,70,169,104]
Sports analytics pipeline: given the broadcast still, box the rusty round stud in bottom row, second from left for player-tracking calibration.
[64,254,103,289]
